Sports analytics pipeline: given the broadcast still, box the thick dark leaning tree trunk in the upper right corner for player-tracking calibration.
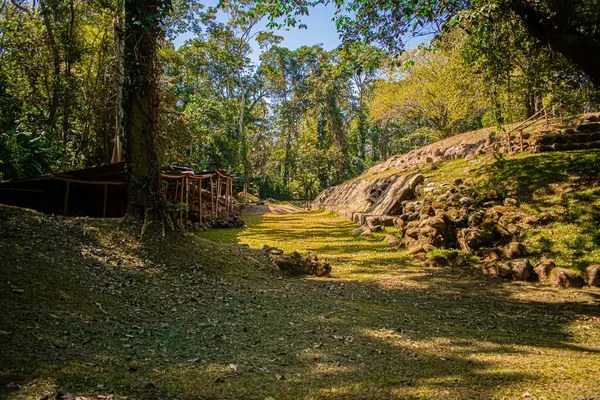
[511,0,600,86]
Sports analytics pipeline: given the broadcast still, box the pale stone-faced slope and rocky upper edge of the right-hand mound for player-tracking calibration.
[312,114,600,217]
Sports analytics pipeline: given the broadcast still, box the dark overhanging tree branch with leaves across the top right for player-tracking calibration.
[260,0,600,85]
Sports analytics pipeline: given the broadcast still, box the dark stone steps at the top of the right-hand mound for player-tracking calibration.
[533,115,600,152]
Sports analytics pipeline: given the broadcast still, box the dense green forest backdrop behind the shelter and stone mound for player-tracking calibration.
[0,0,600,199]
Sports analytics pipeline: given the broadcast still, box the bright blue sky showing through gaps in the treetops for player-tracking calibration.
[175,0,425,63]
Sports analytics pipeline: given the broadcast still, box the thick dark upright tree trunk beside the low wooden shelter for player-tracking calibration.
[123,0,170,225]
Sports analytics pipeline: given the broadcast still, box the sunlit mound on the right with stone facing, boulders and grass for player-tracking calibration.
[312,115,600,280]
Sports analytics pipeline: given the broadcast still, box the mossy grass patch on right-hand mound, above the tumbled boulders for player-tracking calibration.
[426,150,600,271]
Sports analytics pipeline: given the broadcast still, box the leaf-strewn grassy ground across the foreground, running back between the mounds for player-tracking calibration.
[0,203,600,400]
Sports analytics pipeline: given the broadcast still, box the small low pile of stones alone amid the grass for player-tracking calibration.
[263,245,331,276]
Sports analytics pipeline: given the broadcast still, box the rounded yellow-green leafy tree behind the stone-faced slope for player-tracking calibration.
[371,35,487,140]
